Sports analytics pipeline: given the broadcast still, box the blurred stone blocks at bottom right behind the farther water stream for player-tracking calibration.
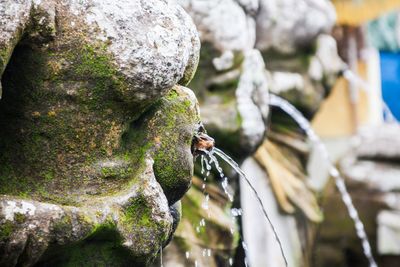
[316,124,400,266]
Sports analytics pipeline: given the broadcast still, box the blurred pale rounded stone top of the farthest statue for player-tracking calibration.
[256,0,336,53]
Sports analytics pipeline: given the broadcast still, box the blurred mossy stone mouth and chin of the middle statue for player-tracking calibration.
[191,50,269,157]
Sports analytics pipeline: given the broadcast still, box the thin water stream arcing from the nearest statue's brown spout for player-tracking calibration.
[208,147,288,266]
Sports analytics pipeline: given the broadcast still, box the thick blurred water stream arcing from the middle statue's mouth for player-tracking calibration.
[270,94,377,267]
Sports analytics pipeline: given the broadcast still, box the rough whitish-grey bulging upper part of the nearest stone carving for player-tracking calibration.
[0,0,199,109]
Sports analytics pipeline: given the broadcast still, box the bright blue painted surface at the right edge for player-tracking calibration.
[380,52,400,120]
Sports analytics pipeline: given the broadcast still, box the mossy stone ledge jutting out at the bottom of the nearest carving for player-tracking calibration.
[0,159,172,266]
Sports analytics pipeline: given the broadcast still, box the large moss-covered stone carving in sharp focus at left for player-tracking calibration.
[0,0,199,266]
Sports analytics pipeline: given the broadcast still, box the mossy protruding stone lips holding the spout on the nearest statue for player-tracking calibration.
[123,87,200,204]
